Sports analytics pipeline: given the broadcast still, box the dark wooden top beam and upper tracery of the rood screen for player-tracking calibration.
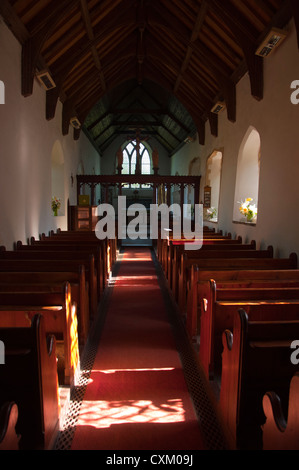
[77,174,200,209]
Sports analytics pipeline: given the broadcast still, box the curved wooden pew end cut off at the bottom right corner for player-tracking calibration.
[262,372,299,450]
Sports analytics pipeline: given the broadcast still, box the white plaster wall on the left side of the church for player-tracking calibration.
[0,21,99,249]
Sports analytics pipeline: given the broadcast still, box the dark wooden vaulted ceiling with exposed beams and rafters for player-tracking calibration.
[0,0,299,155]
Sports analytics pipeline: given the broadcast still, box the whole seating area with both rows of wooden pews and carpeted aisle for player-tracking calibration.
[0,228,299,451]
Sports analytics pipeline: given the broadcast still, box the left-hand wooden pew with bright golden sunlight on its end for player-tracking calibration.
[0,282,80,386]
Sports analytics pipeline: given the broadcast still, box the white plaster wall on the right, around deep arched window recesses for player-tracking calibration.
[172,22,299,257]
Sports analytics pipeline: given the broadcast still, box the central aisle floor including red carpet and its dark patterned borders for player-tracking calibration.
[55,246,226,451]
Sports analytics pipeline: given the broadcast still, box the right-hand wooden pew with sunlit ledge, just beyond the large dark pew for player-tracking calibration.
[199,288,299,378]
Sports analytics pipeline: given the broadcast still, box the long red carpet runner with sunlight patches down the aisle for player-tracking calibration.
[71,248,204,450]
